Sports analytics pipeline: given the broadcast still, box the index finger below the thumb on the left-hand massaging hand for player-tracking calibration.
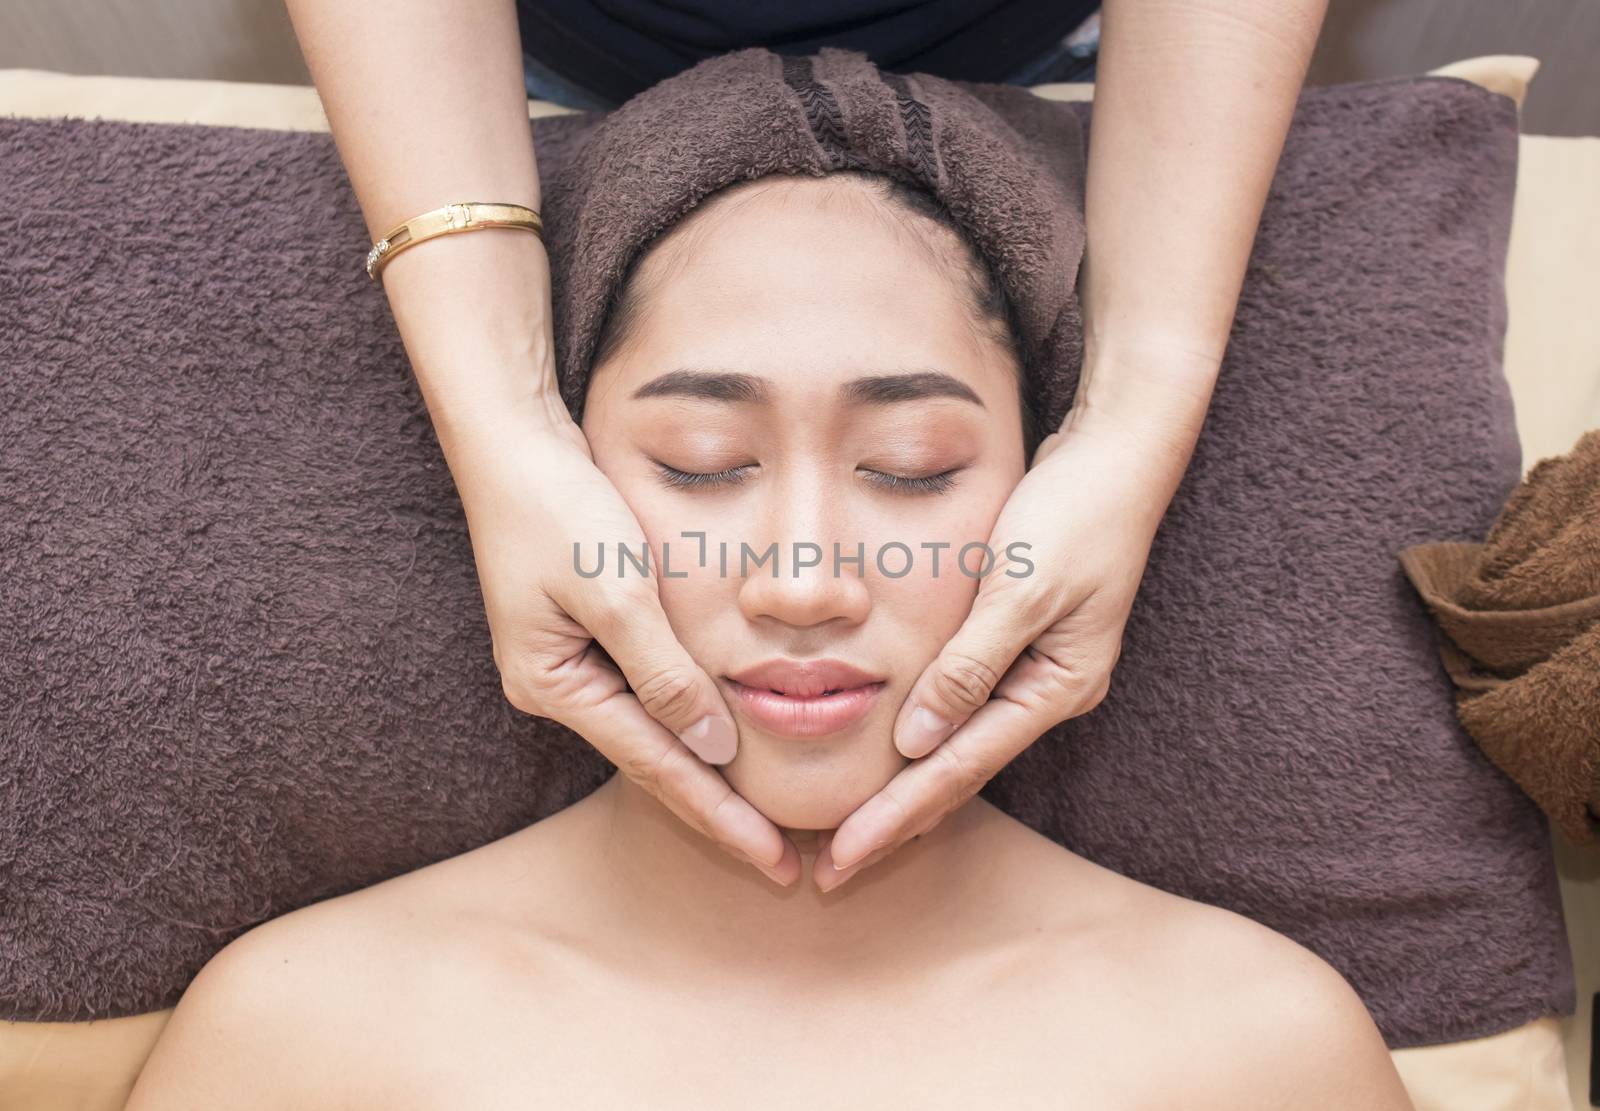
[558,662,800,884]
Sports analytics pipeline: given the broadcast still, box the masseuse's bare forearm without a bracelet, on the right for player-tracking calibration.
[1077,0,1326,466]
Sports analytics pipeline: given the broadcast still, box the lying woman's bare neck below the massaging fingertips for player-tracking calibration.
[586,773,998,970]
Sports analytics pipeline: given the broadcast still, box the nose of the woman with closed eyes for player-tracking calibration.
[730,485,875,628]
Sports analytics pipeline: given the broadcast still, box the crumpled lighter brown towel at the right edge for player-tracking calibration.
[1400,429,1600,845]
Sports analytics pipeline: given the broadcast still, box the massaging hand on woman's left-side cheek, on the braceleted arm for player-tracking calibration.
[446,395,800,885]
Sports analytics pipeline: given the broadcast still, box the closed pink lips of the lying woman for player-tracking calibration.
[726,660,885,736]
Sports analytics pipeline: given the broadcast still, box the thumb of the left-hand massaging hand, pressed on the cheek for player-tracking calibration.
[560,580,739,764]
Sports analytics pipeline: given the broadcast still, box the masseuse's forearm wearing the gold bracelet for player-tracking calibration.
[288,0,554,447]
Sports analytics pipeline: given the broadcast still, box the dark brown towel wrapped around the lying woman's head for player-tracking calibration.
[541,46,1083,429]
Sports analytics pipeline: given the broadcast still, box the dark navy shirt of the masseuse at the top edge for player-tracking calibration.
[517,0,1099,106]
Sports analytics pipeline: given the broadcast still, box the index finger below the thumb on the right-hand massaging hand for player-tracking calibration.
[819,696,1053,871]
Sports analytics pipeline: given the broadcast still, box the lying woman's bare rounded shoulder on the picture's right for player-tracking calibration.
[972,828,1411,1111]
